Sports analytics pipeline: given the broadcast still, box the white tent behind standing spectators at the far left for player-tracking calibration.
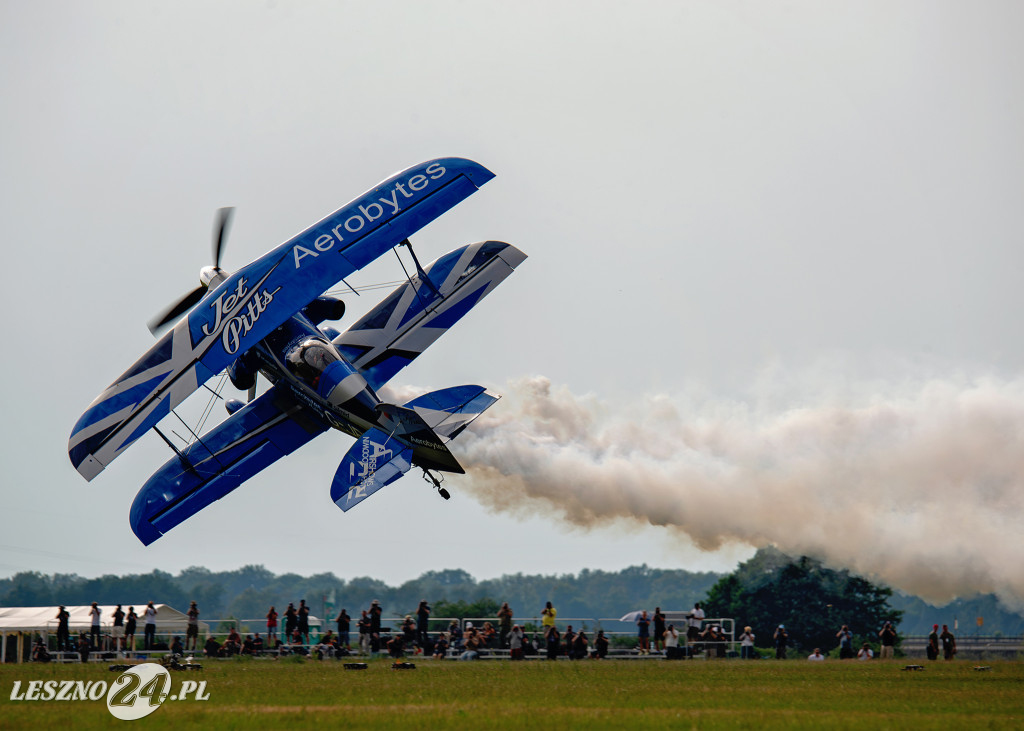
[0,602,210,662]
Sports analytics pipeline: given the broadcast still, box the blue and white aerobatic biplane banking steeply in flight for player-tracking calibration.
[68,158,526,545]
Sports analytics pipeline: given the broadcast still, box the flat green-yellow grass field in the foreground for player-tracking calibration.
[0,658,1024,729]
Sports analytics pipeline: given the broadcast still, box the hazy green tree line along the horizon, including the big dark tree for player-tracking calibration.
[0,549,1024,634]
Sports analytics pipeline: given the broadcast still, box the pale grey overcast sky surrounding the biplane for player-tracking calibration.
[0,0,1024,602]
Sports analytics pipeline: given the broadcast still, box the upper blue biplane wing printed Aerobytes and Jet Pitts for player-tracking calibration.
[68,158,494,480]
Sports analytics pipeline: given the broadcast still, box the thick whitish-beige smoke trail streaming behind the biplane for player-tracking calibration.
[458,378,1024,608]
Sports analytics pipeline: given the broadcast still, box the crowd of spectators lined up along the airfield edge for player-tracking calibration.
[24,599,956,661]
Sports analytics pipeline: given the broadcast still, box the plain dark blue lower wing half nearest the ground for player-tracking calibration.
[130,387,328,546]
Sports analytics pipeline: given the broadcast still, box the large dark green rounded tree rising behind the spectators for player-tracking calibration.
[705,549,902,651]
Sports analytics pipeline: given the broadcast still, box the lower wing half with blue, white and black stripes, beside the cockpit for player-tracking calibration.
[334,242,526,389]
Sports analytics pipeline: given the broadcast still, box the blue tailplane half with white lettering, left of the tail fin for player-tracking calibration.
[331,429,413,511]
